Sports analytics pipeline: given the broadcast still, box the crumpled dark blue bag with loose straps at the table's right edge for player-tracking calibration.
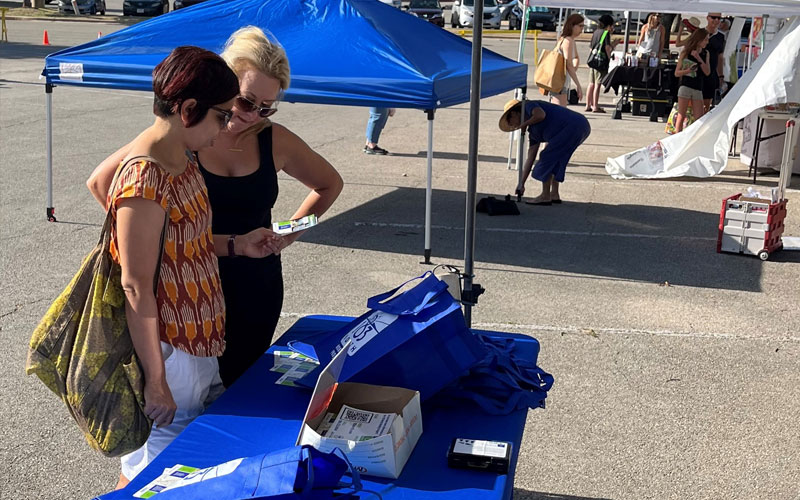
[437,335,554,415]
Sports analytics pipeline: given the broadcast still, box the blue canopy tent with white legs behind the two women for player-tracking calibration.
[43,0,527,270]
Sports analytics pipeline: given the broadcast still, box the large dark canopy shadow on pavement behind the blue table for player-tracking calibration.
[303,188,768,292]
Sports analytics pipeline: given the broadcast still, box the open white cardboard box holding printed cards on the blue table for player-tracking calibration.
[297,342,422,479]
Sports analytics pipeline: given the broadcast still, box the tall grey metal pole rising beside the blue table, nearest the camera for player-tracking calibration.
[461,1,483,328]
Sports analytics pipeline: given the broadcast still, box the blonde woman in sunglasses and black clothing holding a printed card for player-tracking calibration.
[87,26,343,387]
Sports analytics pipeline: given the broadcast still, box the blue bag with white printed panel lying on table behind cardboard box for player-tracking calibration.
[289,271,489,401]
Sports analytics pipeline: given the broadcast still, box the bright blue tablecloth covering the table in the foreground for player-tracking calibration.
[99,316,539,500]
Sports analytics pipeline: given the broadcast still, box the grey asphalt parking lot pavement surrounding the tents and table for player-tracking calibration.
[0,15,800,500]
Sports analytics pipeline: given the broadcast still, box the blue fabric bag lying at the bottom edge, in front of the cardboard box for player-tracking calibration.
[147,445,361,500]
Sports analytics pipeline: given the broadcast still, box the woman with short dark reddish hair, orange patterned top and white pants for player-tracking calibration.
[104,47,239,489]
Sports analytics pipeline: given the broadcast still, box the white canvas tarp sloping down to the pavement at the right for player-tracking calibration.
[606,17,800,179]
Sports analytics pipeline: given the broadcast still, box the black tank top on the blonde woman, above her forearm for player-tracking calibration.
[198,127,278,234]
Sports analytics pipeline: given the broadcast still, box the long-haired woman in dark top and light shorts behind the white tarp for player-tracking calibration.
[675,28,711,133]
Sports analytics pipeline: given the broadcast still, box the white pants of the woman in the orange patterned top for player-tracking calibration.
[120,342,225,480]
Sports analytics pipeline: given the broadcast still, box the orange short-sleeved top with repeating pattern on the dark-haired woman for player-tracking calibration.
[108,158,225,357]
